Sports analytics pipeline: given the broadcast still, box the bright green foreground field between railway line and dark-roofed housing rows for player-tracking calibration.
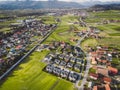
[0,51,73,90]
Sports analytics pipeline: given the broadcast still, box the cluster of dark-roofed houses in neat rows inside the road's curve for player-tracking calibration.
[37,42,86,82]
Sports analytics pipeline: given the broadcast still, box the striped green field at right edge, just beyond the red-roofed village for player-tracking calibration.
[98,23,120,48]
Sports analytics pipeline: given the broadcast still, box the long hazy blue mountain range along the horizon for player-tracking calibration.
[0,1,84,10]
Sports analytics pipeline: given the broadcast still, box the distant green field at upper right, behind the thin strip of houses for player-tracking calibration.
[85,10,120,23]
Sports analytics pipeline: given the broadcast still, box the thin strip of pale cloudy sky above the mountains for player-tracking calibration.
[0,0,120,2]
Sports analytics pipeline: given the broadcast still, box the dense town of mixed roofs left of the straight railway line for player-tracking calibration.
[0,19,55,75]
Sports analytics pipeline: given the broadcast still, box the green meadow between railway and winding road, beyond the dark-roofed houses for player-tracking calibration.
[44,15,86,45]
